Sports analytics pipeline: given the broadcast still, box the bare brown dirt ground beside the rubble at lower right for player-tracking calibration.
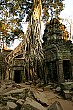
[45,91,73,110]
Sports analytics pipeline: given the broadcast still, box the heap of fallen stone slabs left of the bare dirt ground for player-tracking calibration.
[0,82,48,110]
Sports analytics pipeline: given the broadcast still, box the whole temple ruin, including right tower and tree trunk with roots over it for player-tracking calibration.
[0,0,73,83]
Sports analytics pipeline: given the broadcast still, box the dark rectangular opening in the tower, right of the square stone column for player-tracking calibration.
[63,60,72,80]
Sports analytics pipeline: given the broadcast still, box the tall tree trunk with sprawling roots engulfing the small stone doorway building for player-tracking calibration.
[5,0,44,83]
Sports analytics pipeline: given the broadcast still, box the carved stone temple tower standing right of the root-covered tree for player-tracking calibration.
[43,18,73,83]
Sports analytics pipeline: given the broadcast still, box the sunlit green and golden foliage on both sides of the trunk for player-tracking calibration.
[0,0,64,44]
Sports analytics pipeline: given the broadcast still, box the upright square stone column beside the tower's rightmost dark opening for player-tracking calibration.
[57,60,64,83]
